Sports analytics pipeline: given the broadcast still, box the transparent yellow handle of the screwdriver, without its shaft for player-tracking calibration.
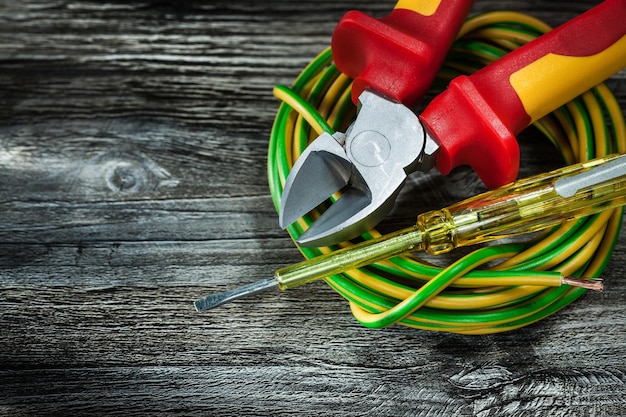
[418,155,626,254]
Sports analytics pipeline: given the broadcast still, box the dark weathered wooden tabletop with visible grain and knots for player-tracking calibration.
[0,0,626,416]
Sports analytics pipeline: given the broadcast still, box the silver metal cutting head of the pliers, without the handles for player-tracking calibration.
[279,90,439,246]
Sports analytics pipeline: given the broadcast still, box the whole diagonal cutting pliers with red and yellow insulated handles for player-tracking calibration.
[279,0,626,246]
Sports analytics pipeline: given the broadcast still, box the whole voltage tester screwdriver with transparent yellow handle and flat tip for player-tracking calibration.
[195,155,626,312]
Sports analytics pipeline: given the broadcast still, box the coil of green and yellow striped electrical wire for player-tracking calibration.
[268,12,626,334]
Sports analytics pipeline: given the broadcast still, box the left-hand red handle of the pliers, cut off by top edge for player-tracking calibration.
[332,0,474,107]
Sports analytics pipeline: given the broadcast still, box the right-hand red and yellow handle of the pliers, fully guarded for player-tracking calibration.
[420,0,626,188]
